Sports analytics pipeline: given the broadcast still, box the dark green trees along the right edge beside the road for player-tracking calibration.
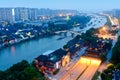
[101,36,120,80]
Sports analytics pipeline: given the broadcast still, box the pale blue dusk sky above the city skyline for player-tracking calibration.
[0,0,120,11]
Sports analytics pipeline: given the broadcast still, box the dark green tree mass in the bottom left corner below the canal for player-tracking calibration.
[0,60,45,80]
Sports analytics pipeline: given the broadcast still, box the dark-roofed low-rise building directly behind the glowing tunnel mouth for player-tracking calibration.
[85,40,110,57]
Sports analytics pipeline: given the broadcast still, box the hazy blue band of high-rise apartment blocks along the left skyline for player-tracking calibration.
[0,7,77,22]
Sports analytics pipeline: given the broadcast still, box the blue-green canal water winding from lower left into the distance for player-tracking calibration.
[0,16,106,70]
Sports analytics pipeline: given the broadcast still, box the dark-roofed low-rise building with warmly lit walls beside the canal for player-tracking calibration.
[35,49,70,74]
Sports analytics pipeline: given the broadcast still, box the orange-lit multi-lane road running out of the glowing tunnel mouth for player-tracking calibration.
[59,57,101,80]
